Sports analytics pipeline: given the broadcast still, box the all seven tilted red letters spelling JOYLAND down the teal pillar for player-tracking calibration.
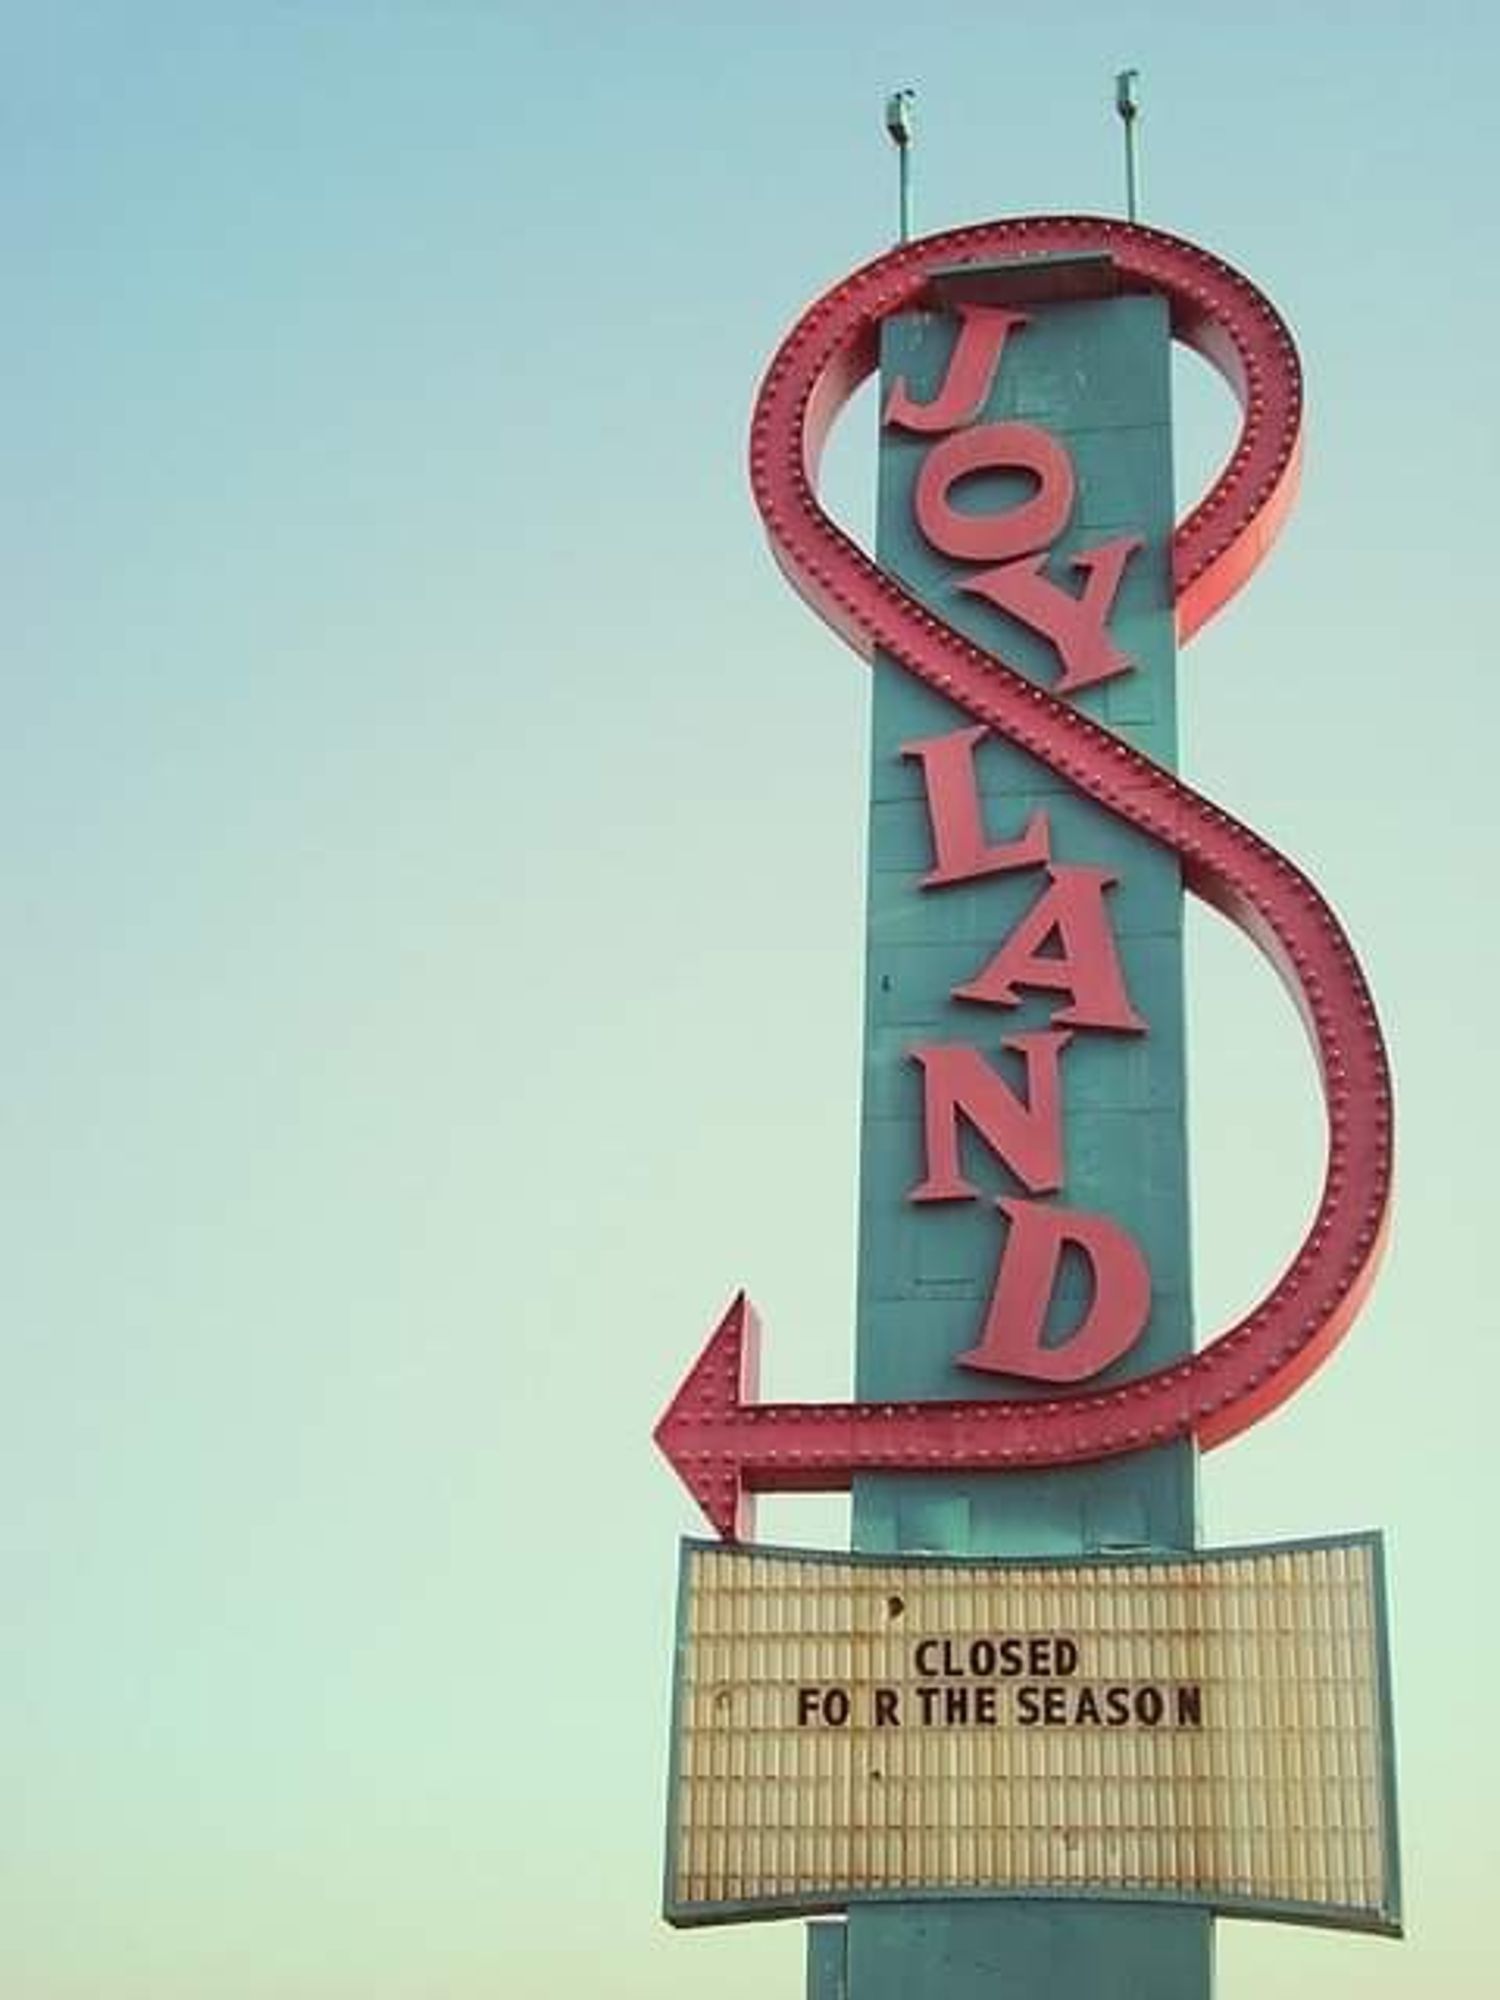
[886,308,1152,1382]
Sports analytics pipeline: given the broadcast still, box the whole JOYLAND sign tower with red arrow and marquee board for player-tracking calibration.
[658,172,1400,2000]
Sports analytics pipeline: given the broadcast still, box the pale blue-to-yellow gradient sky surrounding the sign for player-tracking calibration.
[0,0,1500,2000]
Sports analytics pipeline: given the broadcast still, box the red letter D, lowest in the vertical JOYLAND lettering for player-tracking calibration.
[958,1202,1152,1382]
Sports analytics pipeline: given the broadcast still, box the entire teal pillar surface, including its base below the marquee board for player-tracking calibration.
[848,298,1212,2000]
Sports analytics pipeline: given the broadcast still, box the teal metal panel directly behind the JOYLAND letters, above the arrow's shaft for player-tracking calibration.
[856,298,1192,1440]
